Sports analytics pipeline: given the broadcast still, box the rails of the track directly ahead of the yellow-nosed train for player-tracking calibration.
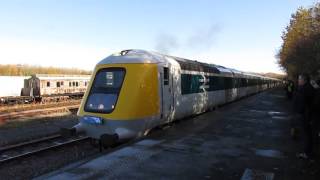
[0,134,90,165]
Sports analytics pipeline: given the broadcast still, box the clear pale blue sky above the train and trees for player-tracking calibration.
[0,0,316,72]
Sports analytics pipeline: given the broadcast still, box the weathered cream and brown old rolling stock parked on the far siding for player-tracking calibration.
[0,74,91,104]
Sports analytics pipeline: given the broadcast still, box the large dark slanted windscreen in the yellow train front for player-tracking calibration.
[84,68,125,113]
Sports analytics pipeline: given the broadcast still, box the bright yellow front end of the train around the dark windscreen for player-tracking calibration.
[78,63,160,120]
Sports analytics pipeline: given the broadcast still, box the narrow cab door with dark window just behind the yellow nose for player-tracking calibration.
[161,67,173,121]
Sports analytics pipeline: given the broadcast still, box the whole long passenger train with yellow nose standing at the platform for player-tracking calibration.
[72,50,278,144]
